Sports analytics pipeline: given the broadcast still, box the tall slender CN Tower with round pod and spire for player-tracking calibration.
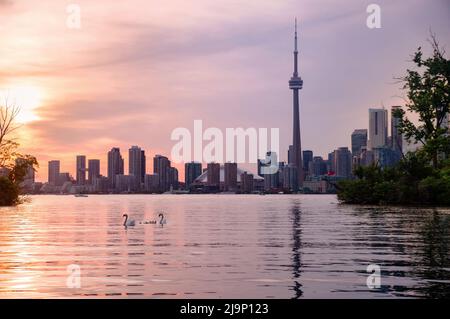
[289,19,303,187]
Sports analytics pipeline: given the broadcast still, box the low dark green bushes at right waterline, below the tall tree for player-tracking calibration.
[338,156,450,206]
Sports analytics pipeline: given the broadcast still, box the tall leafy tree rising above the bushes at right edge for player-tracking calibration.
[394,34,450,168]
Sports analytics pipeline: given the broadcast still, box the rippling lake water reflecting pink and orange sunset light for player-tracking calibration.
[0,195,450,298]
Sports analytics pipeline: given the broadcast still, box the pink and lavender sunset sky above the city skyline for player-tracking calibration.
[0,0,450,180]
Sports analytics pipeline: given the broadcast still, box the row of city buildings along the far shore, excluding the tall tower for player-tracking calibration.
[40,105,408,191]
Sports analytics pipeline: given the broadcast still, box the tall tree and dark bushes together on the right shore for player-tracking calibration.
[336,34,450,206]
